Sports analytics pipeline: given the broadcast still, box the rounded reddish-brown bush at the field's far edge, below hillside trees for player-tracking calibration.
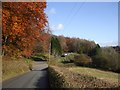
[74,54,92,66]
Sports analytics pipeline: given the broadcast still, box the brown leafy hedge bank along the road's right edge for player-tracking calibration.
[49,66,118,88]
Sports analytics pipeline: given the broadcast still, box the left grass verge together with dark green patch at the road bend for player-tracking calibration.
[1,53,48,81]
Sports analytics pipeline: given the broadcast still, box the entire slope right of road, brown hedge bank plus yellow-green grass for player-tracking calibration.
[49,66,120,88]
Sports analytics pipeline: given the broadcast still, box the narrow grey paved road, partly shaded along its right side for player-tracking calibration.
[2,61,49,90]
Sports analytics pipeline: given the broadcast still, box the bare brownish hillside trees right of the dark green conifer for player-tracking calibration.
[58,36,96,54]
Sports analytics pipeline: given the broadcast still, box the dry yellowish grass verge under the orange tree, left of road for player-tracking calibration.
[2,57,33,81]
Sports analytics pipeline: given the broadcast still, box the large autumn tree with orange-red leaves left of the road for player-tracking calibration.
[2,2,49,57]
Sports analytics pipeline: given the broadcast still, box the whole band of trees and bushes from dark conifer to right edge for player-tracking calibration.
[51,36,120,72]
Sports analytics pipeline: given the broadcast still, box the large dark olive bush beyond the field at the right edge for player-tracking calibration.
[92,47,120,71]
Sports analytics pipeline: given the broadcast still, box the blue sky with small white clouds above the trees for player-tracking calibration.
[45,2,118,46]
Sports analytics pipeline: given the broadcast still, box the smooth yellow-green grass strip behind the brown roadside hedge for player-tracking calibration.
[69,67,120,82]
